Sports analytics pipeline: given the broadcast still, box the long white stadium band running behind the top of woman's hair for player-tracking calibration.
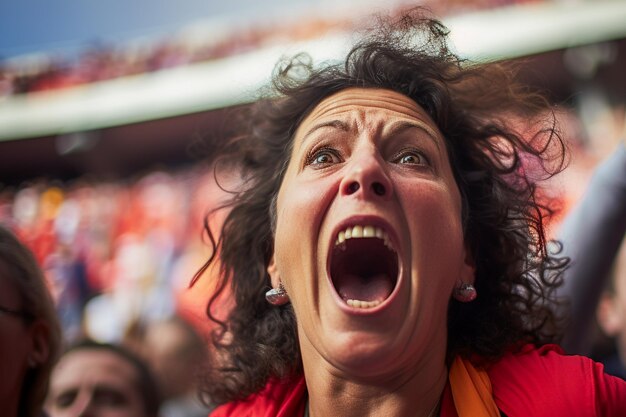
[0,0,626,141]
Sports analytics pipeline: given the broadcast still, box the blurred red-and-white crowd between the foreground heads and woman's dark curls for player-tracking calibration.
[0,162,236,342]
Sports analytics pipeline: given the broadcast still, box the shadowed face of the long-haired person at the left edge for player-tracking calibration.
[0,261,32,415]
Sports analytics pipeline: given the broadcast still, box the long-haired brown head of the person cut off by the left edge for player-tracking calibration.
[0,226,61,417]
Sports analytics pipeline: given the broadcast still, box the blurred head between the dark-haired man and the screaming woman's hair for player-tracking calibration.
[143,317,206,399]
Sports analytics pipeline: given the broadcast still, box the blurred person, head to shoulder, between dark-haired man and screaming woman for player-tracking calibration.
[142,316,210,417]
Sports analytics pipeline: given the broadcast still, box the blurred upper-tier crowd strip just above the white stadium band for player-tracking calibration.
[0,0,541,99]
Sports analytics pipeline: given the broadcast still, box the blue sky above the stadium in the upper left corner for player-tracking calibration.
[0,0,310,58]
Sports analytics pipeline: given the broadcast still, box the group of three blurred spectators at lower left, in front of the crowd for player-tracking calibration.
[0,219,210,417]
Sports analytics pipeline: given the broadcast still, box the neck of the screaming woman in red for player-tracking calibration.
[303,340,448,417]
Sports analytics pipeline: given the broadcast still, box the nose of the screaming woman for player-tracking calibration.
[340,152,393,200]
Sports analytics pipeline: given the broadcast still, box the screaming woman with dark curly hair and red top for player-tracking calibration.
[197,13,626,417]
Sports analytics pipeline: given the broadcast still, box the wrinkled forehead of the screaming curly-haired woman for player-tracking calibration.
[299,88,438,136]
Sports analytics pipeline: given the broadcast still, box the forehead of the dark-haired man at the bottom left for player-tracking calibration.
[51,349,138,390]
